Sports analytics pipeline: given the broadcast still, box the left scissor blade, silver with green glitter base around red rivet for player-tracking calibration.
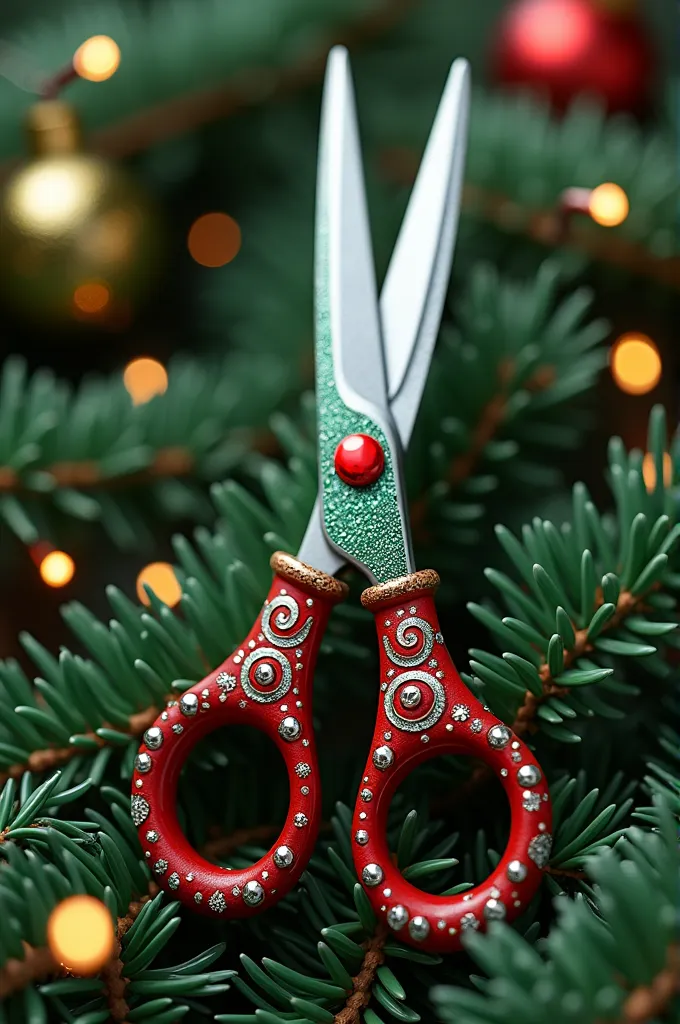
[307,47,413,583]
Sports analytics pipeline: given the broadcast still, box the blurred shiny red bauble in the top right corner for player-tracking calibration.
[492,0,653,113]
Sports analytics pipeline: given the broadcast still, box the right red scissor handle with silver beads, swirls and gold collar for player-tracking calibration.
[352,569,552,952]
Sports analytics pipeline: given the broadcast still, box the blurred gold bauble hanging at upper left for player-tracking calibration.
[0,100,161,325]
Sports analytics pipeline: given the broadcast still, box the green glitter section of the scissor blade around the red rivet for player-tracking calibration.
[314,197,409,583]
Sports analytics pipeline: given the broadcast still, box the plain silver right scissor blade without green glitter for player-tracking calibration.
[380,59,470,451]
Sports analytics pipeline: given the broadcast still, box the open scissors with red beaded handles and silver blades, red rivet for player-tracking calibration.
[131,47,551,951]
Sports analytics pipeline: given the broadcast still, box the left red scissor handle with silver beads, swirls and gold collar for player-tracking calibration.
[131,552,347,918]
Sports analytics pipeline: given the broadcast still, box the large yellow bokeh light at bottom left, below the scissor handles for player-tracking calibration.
[47,896,115,975]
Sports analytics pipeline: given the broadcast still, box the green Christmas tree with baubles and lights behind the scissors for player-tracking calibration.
[0,0,680,1024]
